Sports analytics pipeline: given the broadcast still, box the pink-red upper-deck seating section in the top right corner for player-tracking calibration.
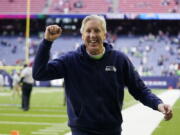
[119,0,180,13]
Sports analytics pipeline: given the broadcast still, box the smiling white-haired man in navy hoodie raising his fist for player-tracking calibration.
[33,15,172,135]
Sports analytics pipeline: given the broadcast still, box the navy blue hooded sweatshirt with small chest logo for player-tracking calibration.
[33,40,162,134]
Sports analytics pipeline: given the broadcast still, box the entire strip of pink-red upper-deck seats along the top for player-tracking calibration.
[0,0,180,14]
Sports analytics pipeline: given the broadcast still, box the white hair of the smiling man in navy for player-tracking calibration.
[80,15,107,34]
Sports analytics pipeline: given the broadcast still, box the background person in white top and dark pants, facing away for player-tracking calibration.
[20,64,34,111]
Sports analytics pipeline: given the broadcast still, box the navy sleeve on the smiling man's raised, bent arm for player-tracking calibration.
[33,39,64,81]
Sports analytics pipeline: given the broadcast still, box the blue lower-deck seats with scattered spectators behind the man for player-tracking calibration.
[0,35,180,76]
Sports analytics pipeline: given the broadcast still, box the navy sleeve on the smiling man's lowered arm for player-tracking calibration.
[124,57,162,110]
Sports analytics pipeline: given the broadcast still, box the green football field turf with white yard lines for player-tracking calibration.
[0,88,180,135]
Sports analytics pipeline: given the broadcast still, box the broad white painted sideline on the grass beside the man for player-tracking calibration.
[65,90,180,135]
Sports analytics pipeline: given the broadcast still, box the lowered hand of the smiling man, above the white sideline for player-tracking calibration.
[158,103,173,120]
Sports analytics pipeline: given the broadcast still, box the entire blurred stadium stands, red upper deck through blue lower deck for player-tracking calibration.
[0,0,180,88]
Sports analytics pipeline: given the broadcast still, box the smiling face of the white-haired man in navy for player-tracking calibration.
[82,19,106,55]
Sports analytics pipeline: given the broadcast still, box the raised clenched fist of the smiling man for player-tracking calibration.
[44,25,62,41]
